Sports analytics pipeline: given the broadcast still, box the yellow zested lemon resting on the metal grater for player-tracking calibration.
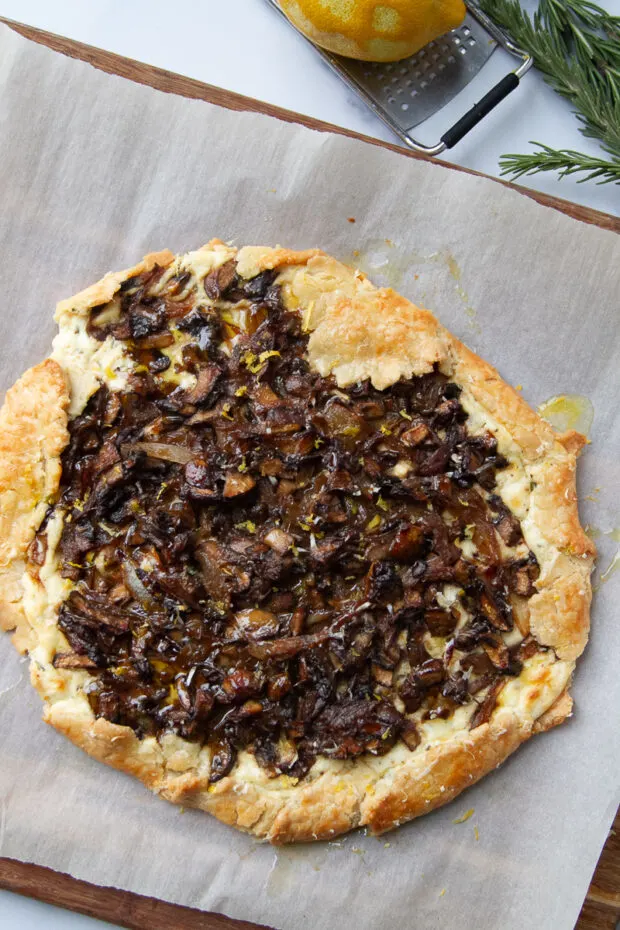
[280,0,465,61]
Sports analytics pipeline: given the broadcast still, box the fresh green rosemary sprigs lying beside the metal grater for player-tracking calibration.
[479,0,620,184]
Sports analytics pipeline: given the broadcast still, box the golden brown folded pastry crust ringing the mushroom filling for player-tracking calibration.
[0,240,595,843]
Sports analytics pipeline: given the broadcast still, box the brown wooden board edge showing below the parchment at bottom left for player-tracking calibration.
[0,858,269,930]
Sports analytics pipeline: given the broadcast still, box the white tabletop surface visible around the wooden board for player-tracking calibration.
[0,0,620,930]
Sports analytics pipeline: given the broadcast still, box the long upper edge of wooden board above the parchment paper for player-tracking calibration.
[0,16,620,233]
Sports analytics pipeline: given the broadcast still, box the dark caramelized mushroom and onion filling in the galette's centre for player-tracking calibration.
[30,262,541,782]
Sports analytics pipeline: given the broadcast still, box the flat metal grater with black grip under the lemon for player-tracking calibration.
[268,0,532,155]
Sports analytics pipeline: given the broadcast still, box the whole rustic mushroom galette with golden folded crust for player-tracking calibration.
[0,240,594,843]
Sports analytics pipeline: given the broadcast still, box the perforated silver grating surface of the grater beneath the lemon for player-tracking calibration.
[324,13,497,132]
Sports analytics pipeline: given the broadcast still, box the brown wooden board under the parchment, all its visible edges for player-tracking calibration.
[0,17,620,930]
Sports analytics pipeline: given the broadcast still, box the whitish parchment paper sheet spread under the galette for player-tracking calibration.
[0,24,620,930]
